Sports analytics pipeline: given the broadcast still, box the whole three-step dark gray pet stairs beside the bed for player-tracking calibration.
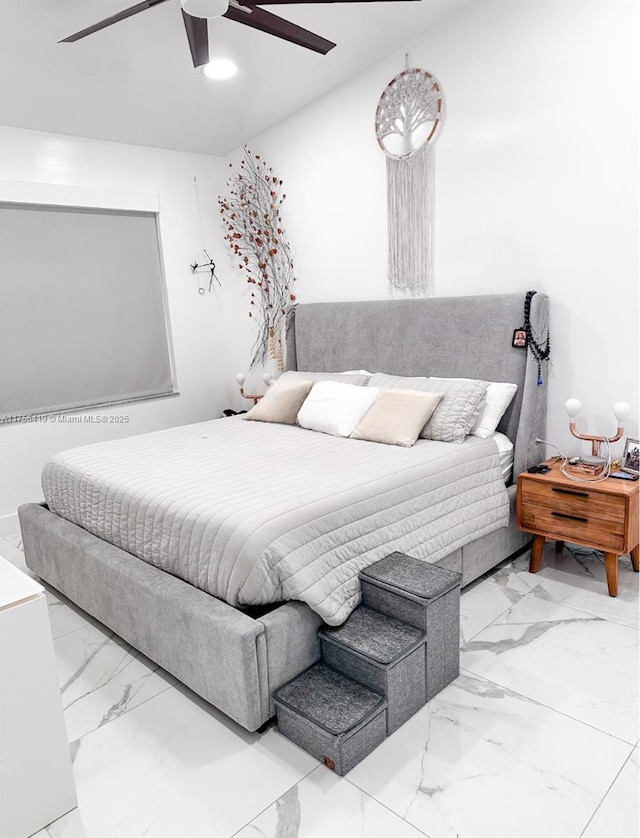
[273,553,460,774]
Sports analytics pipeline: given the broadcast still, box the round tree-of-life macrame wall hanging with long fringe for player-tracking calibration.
[376,55,445,297]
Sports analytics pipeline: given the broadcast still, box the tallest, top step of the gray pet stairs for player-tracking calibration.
[360,553,461,701]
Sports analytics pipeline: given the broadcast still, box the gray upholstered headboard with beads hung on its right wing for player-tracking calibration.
[287,292,549,476]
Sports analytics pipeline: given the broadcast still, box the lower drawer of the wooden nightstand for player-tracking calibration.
[520,503,624,551]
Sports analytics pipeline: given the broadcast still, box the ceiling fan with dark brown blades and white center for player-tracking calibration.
[59,0,420,67]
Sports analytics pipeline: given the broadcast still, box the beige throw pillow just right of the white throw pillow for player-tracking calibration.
[351,390,443,448]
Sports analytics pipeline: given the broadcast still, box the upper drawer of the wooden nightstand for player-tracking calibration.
[521,480,626,529]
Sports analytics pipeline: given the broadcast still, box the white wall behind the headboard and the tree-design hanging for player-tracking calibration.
[240,0,638,460]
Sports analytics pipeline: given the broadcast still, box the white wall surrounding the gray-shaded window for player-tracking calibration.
[0,128,248,533]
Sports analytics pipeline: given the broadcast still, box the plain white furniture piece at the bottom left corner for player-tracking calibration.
[0,556,76,838]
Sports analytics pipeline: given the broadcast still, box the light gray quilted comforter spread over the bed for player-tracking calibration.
[43,418,509,625]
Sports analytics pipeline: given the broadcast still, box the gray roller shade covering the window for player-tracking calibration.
[0,203,175,421]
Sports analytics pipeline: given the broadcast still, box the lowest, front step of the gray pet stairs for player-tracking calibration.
[273,663,387,775]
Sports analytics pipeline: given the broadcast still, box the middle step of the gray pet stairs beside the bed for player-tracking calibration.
[318,606,426,735]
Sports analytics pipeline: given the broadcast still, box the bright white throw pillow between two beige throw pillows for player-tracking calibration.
[298,381,380,436]
